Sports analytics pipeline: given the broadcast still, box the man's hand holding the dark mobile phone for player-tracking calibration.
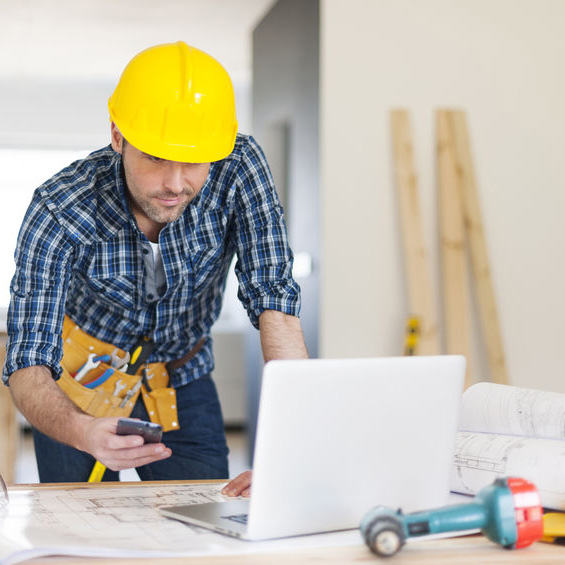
[82,418,172,471]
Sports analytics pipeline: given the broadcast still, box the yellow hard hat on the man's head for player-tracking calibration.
[108,41,237,163]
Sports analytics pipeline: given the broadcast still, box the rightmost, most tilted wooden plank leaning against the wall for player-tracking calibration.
[449,111,509,384]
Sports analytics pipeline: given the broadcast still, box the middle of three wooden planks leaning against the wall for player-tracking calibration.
[436,110,472,387]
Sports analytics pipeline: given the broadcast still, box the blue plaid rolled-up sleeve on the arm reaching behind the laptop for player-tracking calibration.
[230,138,300,327]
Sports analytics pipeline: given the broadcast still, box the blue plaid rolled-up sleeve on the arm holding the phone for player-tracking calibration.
[2,193,73,383]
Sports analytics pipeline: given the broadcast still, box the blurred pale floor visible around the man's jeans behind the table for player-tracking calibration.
[16,429,249,484]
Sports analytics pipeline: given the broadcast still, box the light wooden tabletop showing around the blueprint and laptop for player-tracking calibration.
[4,481,565,565]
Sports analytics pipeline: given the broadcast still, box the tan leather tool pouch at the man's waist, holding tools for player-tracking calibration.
[57,317,179,432]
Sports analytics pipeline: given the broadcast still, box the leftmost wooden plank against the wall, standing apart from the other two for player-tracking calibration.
[391,110,440,355]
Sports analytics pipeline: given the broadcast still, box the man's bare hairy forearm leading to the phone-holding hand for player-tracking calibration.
[10,366,92,449]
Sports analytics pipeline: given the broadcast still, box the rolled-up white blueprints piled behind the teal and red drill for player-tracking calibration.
[451,383,565,510]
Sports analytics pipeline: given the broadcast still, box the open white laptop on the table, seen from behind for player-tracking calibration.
[160,355,465,540]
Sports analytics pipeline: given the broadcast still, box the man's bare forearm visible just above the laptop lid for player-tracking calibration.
[259,310,308,362]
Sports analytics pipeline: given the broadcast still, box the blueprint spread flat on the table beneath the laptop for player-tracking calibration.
[0,483,359,565]
